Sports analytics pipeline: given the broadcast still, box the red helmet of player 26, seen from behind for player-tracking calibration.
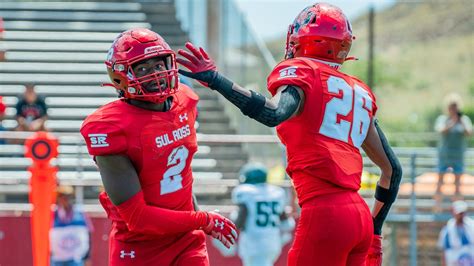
[285,3,354,64]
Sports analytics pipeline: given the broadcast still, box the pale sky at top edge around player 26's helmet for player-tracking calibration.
[235,0,395,40]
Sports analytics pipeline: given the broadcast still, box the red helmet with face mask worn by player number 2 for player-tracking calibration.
[105,28,178,103]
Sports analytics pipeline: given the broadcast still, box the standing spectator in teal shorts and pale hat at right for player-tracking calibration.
[435,94,472,210]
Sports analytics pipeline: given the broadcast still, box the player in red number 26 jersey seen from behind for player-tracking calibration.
[177,3,402,266]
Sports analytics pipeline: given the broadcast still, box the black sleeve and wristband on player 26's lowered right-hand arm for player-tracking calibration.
[374,120,402,235]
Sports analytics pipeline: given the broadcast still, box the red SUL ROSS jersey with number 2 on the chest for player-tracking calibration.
[81,84,199,246]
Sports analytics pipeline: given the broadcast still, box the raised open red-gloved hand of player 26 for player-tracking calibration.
[176,42,217,87]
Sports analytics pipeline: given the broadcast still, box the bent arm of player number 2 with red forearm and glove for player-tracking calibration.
[96,155,237,247]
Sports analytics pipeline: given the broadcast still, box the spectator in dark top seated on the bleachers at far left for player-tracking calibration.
[16,84,48,131]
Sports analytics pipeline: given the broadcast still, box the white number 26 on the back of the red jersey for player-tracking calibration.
[319,76,372,148]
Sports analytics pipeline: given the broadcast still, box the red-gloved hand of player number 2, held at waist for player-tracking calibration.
[202,211,237,248]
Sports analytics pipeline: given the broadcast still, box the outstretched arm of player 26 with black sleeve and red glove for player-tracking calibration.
[177,43,304,127]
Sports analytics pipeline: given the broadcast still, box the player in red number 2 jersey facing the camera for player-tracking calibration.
[81,28,237,266]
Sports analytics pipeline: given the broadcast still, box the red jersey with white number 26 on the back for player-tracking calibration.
[268,57,377,205]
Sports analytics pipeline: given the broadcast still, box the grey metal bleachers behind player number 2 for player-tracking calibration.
[0,1,248,202]
